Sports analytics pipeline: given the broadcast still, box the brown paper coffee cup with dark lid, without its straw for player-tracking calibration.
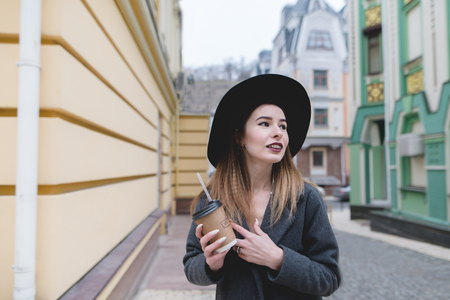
[192,200,237,253]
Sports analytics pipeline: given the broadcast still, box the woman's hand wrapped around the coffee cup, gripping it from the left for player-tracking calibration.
[195,224,228,272]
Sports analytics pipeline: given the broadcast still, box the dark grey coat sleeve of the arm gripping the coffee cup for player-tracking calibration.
[183,199,223,286]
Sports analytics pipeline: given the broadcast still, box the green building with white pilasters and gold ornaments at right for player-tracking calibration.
[348,0,450,246]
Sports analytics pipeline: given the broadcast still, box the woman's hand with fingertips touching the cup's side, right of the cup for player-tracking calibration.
[230,221,284,271]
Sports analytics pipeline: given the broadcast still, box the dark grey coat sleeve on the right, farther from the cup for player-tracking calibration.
[268,188,341,296]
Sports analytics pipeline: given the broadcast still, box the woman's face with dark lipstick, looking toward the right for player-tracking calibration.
[241,104,289,164]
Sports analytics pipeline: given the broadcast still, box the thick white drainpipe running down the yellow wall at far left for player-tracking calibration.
[13,0,41,300]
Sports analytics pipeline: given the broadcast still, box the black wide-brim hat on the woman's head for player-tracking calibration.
[208,74,311,167]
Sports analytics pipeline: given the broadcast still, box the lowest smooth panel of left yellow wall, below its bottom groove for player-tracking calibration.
[36,177,157,299]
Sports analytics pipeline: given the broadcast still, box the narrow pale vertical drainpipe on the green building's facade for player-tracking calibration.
[381,0,392,204]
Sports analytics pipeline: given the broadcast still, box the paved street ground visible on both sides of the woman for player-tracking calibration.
[134,201,450,300]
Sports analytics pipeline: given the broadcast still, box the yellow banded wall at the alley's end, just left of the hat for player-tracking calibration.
[175,114,209,198]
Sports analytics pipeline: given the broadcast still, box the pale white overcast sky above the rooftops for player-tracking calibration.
[179,0,345,68]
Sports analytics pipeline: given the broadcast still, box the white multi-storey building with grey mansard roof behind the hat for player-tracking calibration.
[270,0,353,192]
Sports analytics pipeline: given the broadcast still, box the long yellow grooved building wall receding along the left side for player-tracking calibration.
[0,0,178,299]
